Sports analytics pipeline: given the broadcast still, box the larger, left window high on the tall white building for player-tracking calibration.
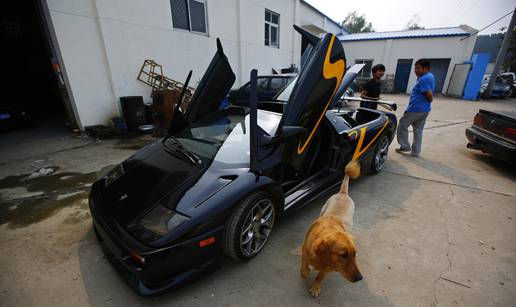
[170,0,208,34]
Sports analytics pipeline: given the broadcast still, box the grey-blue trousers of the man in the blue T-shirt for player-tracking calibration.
[397,111,429,156]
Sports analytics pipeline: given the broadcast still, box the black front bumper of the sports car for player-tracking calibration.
[89,192,222,296]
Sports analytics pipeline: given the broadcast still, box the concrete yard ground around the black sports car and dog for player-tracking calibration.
[0,95,516,306]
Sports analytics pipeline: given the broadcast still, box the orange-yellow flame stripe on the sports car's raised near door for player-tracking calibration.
[297,35,346,155]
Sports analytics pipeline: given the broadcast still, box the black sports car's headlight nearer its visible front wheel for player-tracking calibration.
[140,205,189,236]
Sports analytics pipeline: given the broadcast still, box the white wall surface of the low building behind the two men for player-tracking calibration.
[342,35,476,93]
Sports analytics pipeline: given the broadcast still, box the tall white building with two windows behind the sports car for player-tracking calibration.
[40,0,345,129]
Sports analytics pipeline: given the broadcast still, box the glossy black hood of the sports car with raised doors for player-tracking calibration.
[98,140,249,228]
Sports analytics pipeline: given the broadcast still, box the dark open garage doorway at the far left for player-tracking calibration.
[0,0,77,137]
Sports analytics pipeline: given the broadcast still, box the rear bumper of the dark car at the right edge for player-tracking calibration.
[466,126,516,163]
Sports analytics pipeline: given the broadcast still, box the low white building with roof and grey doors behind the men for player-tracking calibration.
[339,25,477,93]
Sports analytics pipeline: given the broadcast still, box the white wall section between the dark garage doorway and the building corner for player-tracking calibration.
[48,0,118,128]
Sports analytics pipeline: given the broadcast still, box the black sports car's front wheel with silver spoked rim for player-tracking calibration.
[222,192,276,261]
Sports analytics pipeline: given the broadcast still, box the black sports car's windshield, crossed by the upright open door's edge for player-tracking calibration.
[170,108,281,168]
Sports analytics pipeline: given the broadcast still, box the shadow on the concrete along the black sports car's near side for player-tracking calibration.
[79,161,420,306]
